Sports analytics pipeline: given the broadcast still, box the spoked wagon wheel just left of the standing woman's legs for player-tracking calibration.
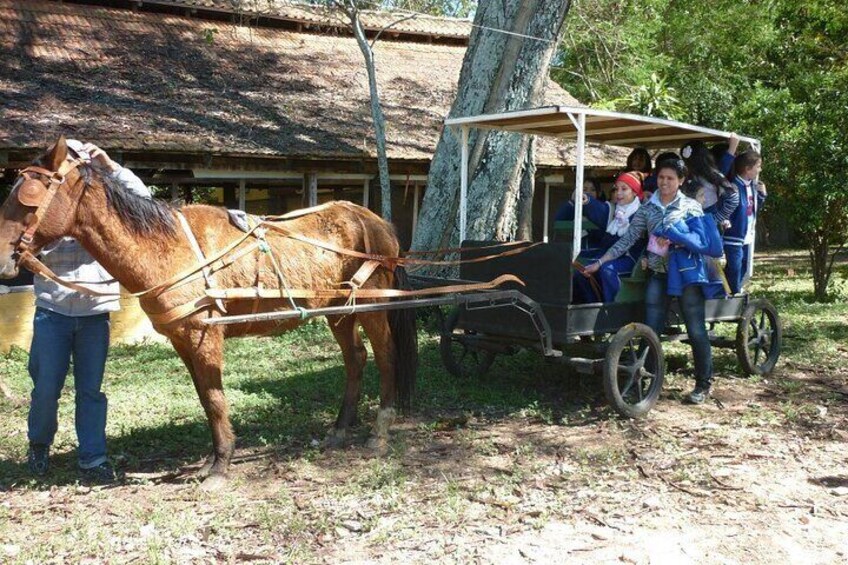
[604,324,665,418]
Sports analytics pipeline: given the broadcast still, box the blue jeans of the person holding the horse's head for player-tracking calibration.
[29,308,109,469]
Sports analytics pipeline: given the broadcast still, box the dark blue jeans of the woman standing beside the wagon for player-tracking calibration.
[645,273,713,388]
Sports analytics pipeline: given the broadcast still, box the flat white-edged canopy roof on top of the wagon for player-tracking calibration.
[445,106,758,149]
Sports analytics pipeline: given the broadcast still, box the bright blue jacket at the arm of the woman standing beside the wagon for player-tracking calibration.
[654,214,722,297]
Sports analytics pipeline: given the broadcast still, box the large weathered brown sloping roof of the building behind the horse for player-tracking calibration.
[0,0,620,166]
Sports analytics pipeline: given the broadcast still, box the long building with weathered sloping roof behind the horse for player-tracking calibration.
[0,0,624,349]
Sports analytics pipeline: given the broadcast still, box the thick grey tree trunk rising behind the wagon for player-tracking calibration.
[413,0,570,266]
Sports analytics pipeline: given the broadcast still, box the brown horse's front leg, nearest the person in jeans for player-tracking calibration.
[174,328,235,489]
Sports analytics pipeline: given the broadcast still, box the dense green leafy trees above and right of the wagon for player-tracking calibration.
[553,0,848,300]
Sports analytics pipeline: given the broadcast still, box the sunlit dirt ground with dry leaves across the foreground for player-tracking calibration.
[0,364,848,563]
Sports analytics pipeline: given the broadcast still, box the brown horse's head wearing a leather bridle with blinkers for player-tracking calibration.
[0,136,85,278]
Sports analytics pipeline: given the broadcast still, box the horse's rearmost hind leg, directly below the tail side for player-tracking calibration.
[357,312,397,452]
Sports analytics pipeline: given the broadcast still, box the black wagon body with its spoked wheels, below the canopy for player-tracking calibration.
[418,236,781,417]
